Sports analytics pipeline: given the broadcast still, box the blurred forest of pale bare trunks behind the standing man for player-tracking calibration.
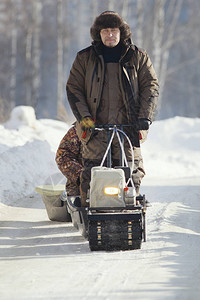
[0,0,200,122]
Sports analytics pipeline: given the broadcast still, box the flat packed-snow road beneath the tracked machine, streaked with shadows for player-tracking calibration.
[0,179,200,300]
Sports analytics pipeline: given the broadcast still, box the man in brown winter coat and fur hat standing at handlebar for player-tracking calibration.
[66,11,158,205]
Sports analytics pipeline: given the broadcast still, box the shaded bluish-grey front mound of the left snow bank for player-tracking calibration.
[0,140,57,202]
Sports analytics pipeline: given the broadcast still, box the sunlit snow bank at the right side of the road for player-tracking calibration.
[142,117,200,179]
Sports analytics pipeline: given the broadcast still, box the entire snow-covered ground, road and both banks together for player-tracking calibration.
[0,107,200,300]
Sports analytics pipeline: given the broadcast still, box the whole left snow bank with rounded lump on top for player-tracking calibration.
[0,106,69,204]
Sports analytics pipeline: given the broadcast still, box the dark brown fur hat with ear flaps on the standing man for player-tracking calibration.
[90,11,131,42]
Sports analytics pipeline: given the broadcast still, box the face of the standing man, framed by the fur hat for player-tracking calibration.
[100,28,120,48]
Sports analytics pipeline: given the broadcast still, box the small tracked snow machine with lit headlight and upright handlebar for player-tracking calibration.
[61,125,146,251]
